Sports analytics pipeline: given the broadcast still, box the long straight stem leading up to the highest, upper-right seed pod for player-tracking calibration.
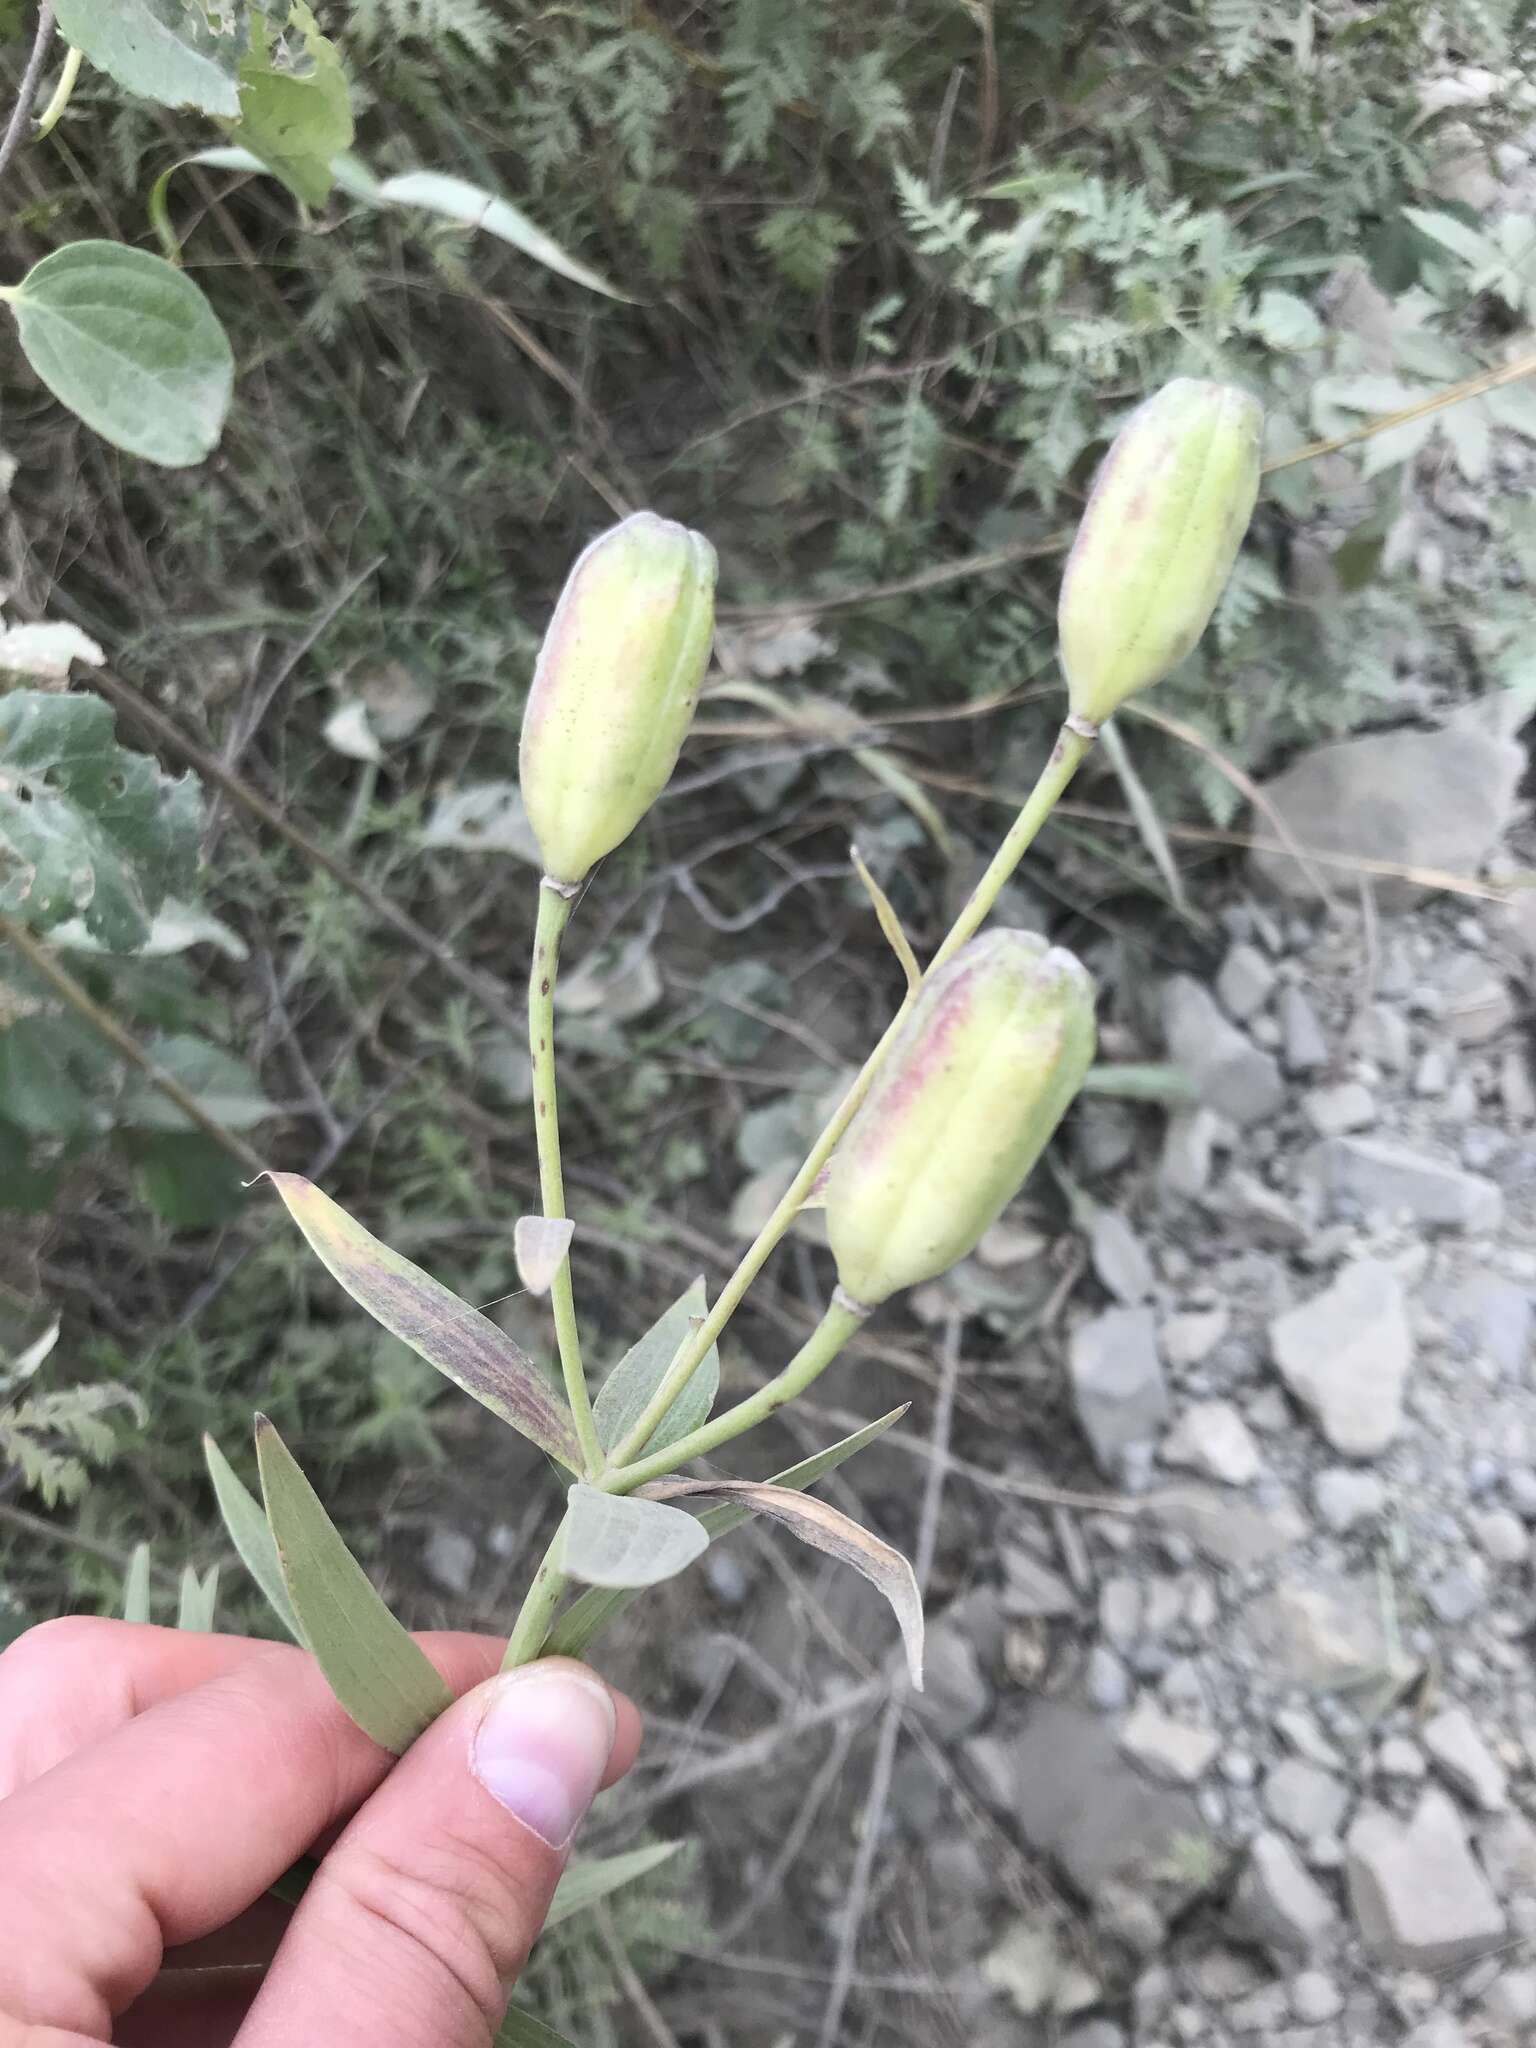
[612,725,1094,1477]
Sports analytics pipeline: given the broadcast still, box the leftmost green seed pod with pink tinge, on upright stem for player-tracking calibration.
[520,512,717,885]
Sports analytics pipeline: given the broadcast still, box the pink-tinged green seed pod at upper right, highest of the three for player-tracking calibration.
[1057,377,1264,727]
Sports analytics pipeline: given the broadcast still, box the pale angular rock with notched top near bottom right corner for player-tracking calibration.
[1346,1788,1505,1972]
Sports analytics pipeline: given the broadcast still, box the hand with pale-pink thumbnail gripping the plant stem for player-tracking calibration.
[0,1618,639,2048]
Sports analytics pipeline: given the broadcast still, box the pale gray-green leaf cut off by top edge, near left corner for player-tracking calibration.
[53,0,246,117]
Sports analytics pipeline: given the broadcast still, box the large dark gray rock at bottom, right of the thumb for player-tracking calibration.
[1014,1700,1223,1919]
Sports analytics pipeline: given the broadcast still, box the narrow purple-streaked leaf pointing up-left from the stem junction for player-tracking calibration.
[268,1174,582,1473]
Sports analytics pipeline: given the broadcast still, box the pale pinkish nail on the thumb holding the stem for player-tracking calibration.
[469,1665,616,1849]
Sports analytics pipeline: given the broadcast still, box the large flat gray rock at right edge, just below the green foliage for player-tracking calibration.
[1249,707,1526,909]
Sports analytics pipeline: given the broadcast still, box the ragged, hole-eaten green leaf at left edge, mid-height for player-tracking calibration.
[0,690,203,952]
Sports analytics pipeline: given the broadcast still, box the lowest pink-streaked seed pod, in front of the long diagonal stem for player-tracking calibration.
[825,932,1096,1309]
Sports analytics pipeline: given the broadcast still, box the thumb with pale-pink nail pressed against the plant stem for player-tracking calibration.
[238,1659,633,2048]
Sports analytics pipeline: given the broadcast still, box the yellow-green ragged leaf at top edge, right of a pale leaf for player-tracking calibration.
[229,0,352,207]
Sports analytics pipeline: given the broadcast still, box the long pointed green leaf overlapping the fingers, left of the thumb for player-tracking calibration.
[256,1415,453,1757]
